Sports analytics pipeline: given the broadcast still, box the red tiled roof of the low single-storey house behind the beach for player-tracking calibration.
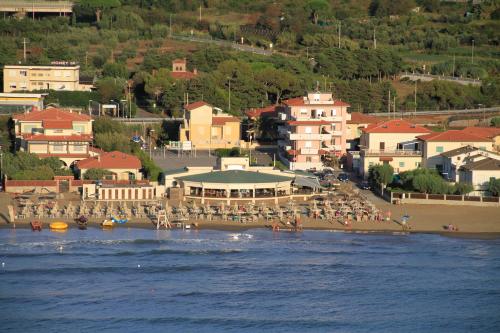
[77,151,142,169]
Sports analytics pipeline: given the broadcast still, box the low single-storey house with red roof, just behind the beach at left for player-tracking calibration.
[75,151,142,180]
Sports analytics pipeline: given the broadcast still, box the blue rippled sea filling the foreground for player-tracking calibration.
[0,229,500,333]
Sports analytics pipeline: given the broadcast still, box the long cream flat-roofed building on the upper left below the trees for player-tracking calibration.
[3,65,93,93]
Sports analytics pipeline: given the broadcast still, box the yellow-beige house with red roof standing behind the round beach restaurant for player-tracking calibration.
[179,101,241,149]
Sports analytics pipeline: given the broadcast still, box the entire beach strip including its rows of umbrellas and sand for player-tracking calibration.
[0,185,500,235]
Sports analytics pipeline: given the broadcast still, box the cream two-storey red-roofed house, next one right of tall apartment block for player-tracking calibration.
[357,119,431,178]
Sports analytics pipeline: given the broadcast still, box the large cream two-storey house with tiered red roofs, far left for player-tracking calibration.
[12,108,95,166]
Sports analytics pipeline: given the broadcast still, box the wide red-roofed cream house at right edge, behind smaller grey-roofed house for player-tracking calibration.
[418,130,493,171]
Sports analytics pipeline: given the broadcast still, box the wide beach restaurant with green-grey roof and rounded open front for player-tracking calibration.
[164,157,321,204]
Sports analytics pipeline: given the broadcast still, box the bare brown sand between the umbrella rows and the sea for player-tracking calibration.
[0,189,500,237]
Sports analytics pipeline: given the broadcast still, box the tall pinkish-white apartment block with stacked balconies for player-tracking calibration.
[278,92,350,170]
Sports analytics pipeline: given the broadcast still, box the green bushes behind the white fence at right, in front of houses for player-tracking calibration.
[400,168,473,195]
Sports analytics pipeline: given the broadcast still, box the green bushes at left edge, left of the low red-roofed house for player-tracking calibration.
[2,152,73,180]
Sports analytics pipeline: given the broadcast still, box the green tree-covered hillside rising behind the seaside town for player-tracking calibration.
[0,0,500,116]
